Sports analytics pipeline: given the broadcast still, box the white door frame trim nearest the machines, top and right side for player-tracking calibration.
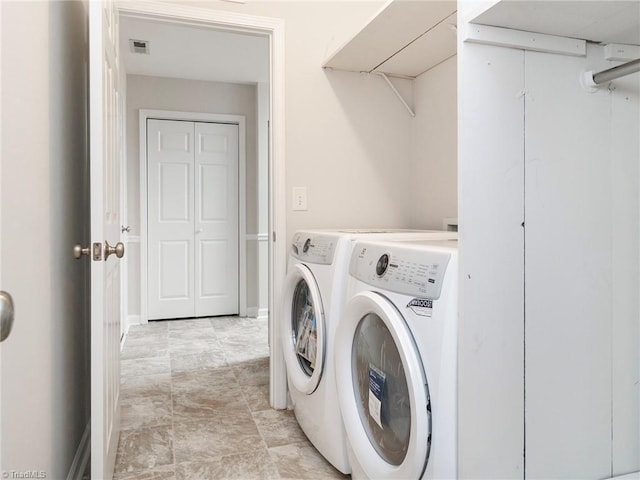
[117,0,287,409]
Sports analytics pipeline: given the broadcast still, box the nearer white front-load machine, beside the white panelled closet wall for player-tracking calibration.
[334,240,458,479]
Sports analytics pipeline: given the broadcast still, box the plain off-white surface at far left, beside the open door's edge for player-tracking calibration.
[0,2,90,478]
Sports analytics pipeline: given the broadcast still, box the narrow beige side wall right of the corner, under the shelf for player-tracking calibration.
[410,57,458,230]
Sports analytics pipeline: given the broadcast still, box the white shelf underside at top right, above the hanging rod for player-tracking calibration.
[473,0,640,45]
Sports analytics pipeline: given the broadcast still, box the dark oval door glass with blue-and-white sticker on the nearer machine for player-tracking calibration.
[351,313,411,465]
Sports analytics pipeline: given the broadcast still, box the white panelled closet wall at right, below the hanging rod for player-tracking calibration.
[458,2,640,478]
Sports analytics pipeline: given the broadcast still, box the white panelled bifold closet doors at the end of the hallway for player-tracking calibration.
[147,120,238,319]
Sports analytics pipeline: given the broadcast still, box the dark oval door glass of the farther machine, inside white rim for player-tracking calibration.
[291,279,318,377]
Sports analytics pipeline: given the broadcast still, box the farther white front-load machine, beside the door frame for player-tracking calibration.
[282,230,457,473]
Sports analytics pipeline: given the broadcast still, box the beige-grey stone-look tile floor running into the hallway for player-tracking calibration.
[114,317,349,480]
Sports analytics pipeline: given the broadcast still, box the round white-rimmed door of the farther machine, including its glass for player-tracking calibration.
[282,264,325,394]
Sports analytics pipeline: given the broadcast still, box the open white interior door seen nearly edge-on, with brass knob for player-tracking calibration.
[89,1,121,478]
